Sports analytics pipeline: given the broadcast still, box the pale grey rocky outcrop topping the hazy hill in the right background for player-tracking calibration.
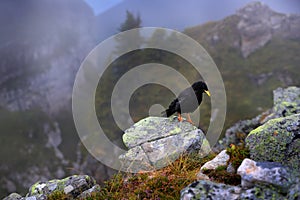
[236,2,300,57]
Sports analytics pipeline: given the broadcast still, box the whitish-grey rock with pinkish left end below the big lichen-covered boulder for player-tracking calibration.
[237,158,300,193]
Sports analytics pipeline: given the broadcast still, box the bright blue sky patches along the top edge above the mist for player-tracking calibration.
[85,0,300,15]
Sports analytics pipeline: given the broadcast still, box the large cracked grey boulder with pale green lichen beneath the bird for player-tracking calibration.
[119,117,210,172]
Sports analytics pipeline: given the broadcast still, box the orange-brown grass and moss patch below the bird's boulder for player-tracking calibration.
[96,153,215,200]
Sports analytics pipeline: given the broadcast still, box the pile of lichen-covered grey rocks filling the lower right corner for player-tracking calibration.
[181,87,300,200]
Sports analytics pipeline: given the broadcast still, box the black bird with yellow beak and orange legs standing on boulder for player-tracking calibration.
[162,81,210,124]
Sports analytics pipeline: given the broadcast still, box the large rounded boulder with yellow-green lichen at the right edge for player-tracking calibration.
[246,114,300,170]
